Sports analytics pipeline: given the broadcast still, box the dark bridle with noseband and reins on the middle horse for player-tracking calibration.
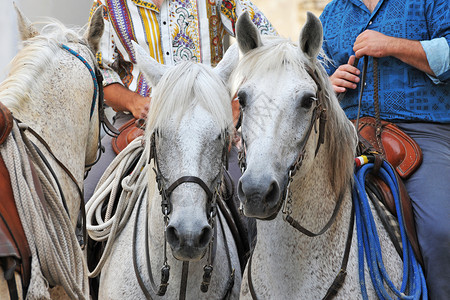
[133,130,234,299]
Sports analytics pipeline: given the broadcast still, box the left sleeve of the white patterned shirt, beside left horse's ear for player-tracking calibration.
[91,1,122,86]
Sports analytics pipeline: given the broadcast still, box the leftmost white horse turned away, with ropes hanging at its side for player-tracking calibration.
[0,5,103,299]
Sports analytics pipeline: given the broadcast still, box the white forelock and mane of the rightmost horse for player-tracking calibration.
[232,36,356,195]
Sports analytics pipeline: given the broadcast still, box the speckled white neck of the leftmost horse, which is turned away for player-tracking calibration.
[4,44,98,224]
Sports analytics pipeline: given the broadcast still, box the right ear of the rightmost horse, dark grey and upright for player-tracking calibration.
[299,11,323,60]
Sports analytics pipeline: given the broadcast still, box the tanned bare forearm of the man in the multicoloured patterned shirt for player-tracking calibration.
[104,83,150,119]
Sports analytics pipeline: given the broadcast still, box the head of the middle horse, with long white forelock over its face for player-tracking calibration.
[134,43,238,261]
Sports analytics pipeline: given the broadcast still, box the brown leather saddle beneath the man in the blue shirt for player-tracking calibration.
[352,117,423,265]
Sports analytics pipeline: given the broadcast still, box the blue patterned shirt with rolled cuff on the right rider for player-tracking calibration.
[320,0,450,123]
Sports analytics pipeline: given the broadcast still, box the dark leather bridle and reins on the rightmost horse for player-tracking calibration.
[238,66,355,300]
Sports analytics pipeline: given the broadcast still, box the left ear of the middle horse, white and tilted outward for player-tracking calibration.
[131,41,169,86]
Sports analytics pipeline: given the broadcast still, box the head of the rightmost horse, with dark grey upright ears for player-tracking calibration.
[235,13,356,219]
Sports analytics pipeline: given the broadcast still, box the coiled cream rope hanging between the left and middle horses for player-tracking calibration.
[86,136,148,278]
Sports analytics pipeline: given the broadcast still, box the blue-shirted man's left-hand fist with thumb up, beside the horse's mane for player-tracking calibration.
[330,55,360,93]
